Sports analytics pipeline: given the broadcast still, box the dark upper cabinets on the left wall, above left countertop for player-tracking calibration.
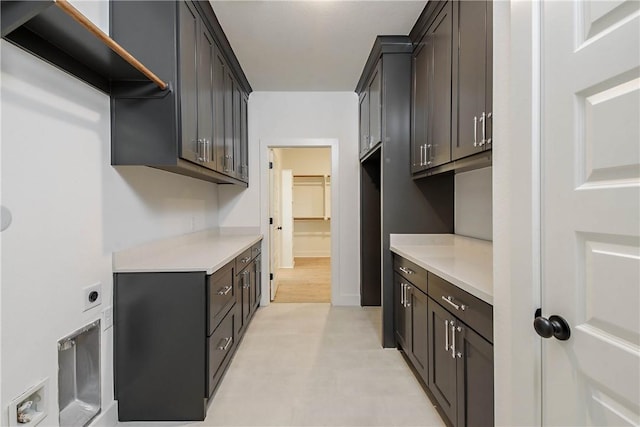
[110,1,251,185]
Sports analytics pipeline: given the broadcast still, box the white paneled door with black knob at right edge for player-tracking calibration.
[542,1,640,426]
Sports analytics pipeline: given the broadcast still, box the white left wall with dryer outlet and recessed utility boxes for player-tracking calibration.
[0,1,218,426]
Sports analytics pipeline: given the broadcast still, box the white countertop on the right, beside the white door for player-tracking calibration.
[390,234,493,305]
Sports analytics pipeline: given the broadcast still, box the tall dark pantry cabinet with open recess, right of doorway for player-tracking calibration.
[356,36,453,347]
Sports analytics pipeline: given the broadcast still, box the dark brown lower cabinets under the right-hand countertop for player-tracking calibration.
[393,255,494,427]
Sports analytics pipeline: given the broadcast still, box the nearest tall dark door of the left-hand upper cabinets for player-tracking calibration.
[178,1,199,166]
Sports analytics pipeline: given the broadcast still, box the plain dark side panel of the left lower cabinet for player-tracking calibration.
[113,272,207,421]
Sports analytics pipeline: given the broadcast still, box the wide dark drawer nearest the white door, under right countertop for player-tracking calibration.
[428,272,493,343]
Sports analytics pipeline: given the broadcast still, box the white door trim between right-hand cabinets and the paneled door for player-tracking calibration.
[492,2,542,426]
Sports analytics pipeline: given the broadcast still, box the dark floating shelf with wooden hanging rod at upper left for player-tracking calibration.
[0,0,169,95]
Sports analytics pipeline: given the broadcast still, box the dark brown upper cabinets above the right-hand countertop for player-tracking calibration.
[410,1,493,178]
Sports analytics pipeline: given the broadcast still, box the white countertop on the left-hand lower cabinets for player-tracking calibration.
[113,229,262,274]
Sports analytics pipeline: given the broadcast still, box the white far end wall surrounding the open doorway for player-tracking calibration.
[219,92,360,305]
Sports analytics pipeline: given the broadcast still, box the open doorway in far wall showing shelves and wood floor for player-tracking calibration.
[269,147,332,303]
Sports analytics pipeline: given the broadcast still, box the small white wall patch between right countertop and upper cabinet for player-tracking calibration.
[454,167,493,240]
